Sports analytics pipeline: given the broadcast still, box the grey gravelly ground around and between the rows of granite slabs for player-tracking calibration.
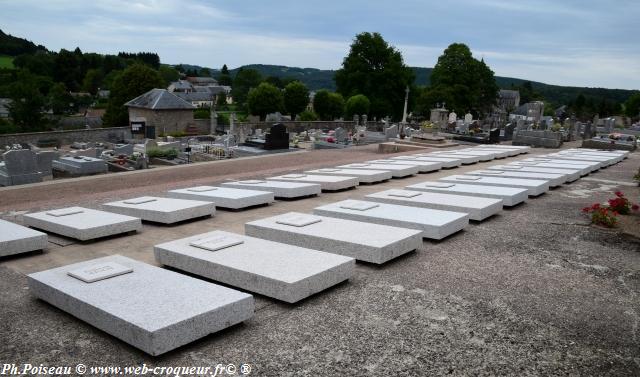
[0,145,640,376]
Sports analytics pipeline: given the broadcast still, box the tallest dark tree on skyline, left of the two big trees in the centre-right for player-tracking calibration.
[335,33,415,118]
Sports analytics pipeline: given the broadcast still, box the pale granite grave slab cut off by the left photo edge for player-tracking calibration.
[0,220,47,257]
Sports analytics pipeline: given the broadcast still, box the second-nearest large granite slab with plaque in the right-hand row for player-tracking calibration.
[153,231,355,303]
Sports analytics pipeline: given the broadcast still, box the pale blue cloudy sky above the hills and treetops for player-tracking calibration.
[0,0,640,89]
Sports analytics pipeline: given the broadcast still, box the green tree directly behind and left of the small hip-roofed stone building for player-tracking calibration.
[103,64,164,127]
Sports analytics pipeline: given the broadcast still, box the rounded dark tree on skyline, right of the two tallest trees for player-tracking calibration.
[420,43,498,116]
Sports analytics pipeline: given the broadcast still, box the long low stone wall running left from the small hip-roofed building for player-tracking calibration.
[0,127,131,147]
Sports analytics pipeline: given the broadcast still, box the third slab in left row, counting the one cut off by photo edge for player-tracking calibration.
[103,196,216,224]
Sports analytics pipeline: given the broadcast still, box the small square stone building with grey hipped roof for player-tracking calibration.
[124,89,196,138]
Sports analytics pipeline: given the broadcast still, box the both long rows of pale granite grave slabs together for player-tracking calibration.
[0,145,628,355]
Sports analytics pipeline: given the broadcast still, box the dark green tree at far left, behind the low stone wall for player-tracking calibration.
[9,70,45,132]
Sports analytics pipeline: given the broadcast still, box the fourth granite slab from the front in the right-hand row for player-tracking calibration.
[313,200,469,240]
